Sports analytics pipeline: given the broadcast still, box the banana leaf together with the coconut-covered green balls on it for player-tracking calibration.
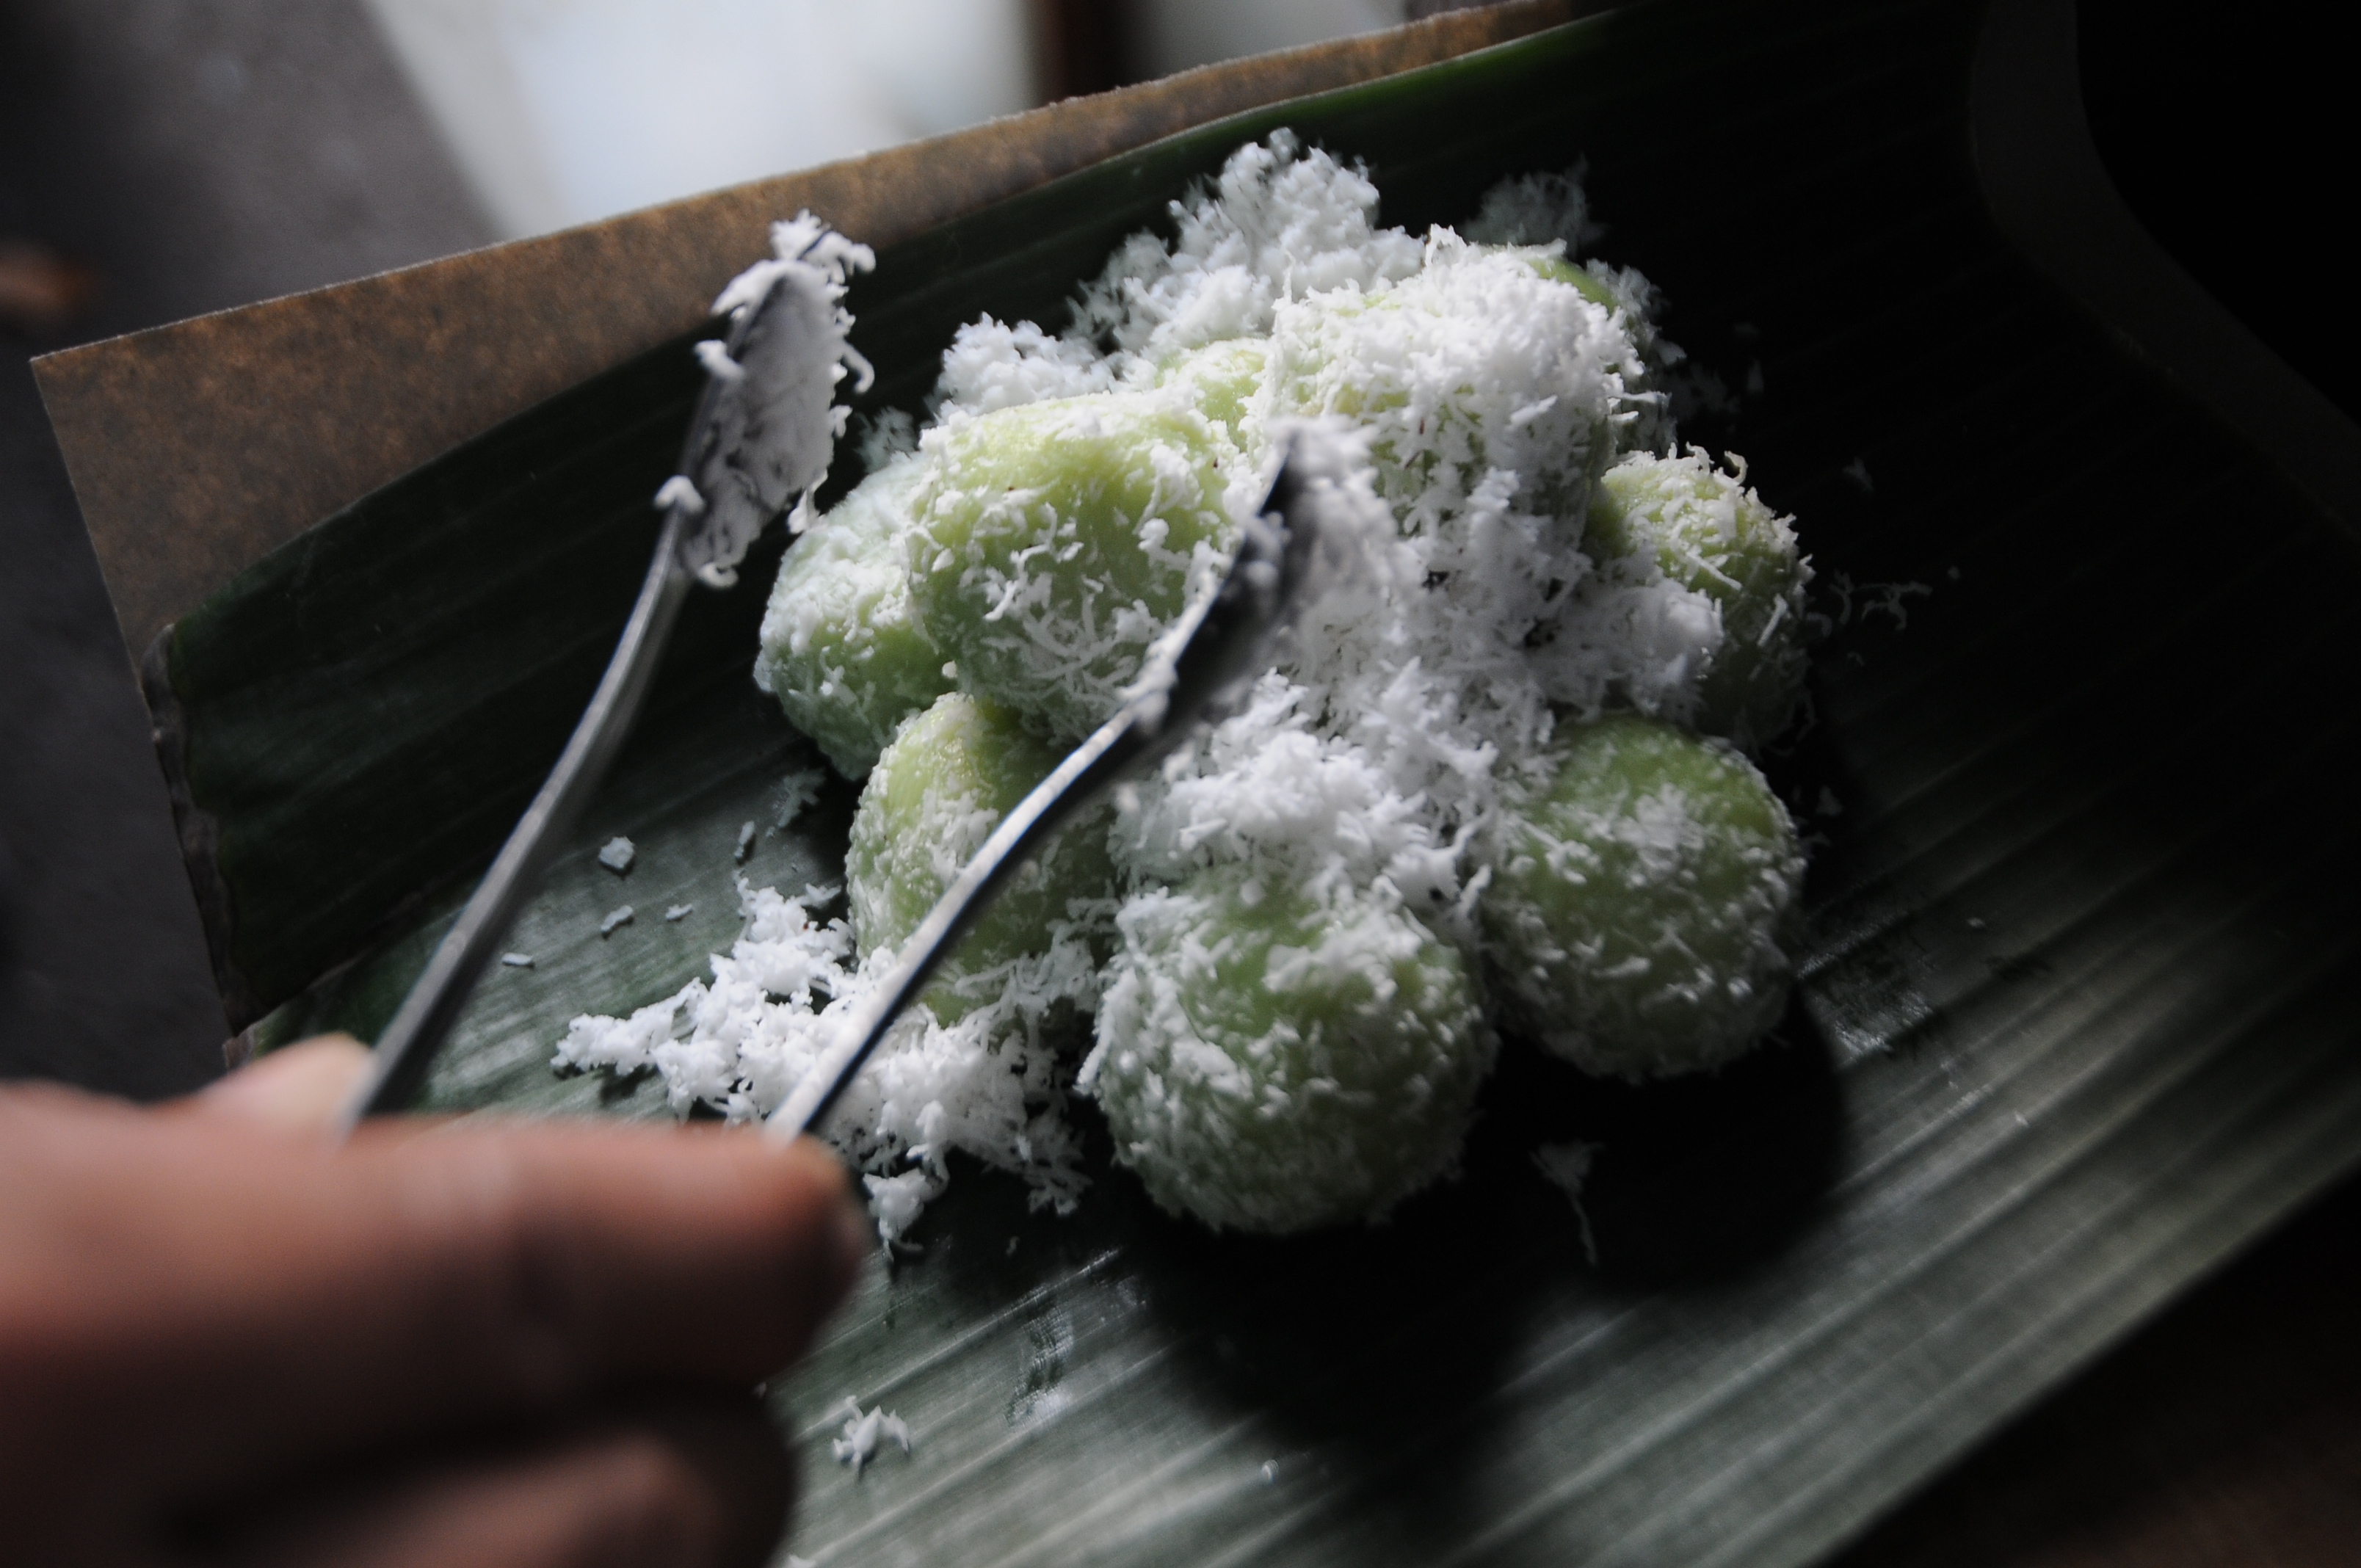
[149,0,2361,1568]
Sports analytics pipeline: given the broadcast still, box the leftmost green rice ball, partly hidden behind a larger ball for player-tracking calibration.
[753,456,951,780]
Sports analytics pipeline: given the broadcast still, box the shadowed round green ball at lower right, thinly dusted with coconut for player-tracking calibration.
[1483,713,1804,1079]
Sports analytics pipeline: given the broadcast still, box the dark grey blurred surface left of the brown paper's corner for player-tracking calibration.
[0,0,491,1098]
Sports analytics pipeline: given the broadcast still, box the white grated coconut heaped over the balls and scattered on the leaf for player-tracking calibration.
[555,132,1785,1246]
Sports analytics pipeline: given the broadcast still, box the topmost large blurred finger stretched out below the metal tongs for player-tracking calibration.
[0,1096,868,1492]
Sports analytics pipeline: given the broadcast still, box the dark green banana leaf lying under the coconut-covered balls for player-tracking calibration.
[151,0,2361,1568]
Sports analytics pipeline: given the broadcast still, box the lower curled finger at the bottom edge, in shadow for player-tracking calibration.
[208,1395,791,1568]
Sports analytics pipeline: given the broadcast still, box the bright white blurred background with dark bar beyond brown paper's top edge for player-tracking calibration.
[369,0,1433,236]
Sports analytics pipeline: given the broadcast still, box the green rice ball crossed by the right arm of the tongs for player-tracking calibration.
[845,692,1114,1023]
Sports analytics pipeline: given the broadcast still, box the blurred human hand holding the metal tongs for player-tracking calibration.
[0,1042,868,1568]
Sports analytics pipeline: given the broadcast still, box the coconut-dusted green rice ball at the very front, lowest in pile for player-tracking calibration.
[1084,864,1495,1235]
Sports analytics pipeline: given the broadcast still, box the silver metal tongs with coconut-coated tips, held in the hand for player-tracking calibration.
[340,236,1313,1139]
